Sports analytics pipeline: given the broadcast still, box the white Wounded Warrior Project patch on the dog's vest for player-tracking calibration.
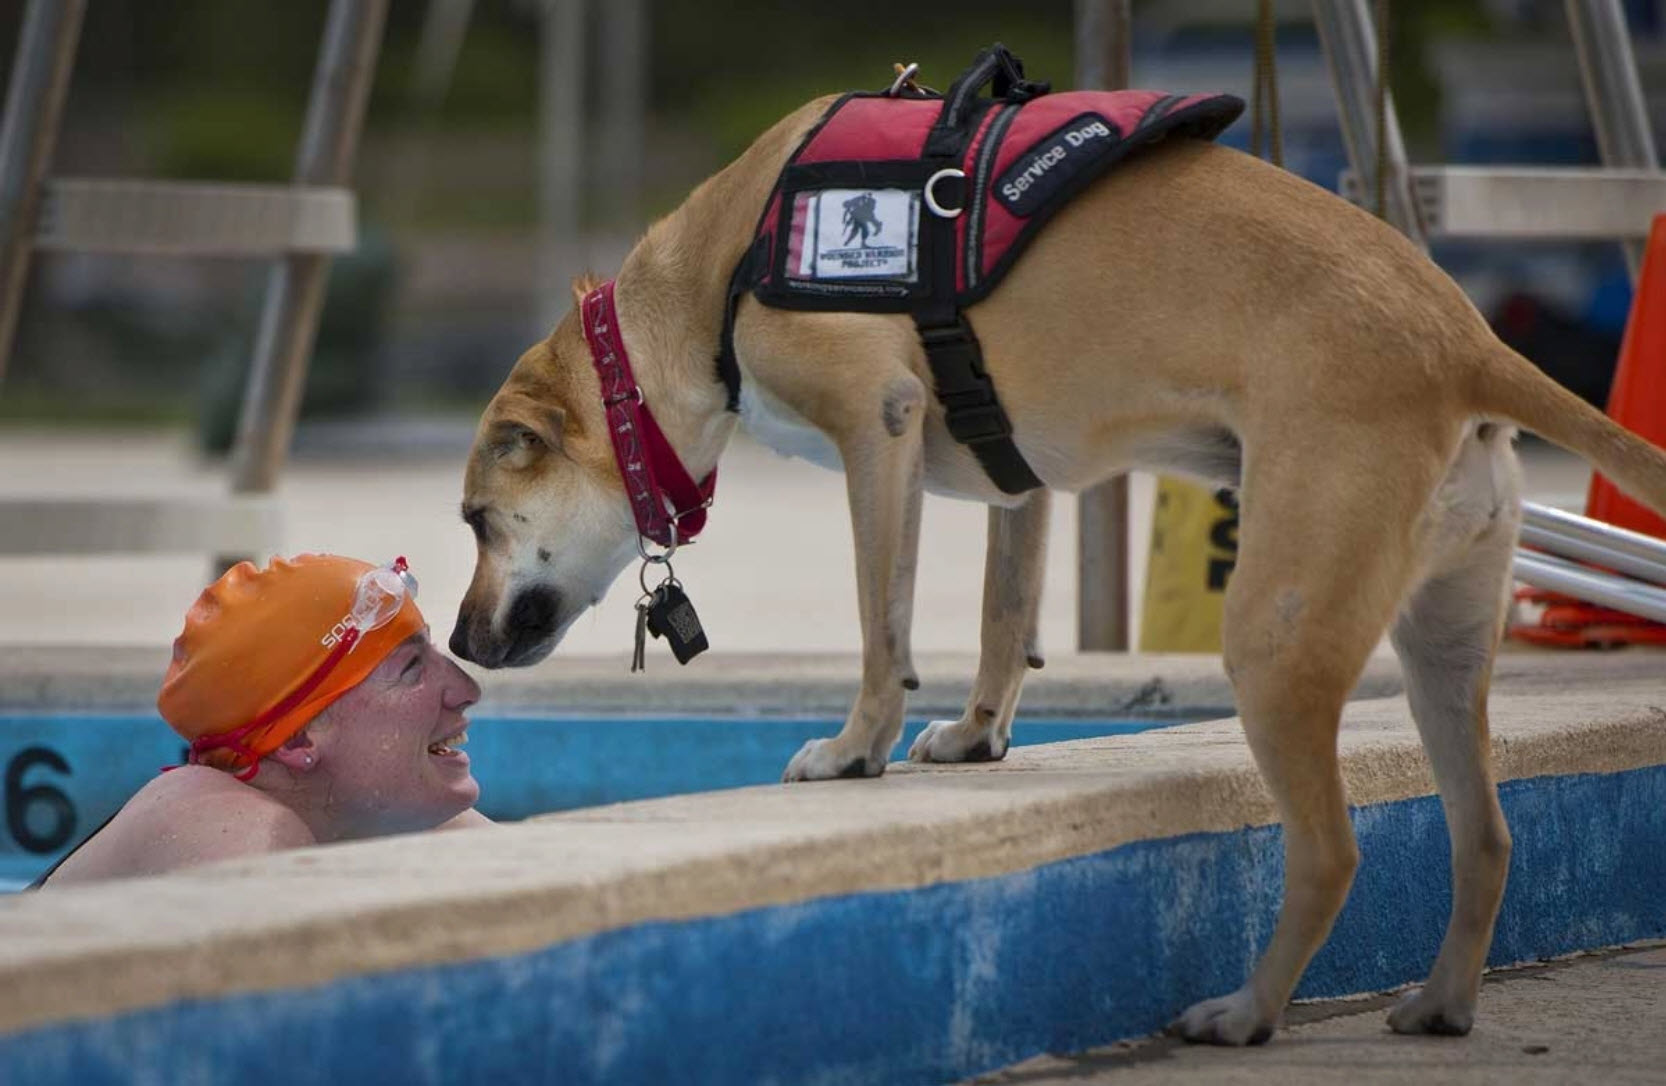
[786,188,920,283]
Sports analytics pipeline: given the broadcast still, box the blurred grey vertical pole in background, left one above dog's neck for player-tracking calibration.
[538,0,585,336]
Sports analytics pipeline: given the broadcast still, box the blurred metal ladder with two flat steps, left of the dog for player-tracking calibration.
[0,0,387,563]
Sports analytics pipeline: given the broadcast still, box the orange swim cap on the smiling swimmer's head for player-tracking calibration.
[157,555,425,776]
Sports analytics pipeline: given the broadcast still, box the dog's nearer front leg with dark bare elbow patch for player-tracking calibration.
[781,371,926,781]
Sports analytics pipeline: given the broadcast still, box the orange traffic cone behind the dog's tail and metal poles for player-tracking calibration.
[1511,215,1666,646]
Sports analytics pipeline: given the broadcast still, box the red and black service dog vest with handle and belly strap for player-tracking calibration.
[718,45,1243,493]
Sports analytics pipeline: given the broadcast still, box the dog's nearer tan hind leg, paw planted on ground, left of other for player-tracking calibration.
[1171,420,1456,1044]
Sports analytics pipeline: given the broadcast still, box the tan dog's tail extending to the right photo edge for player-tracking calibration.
[1471,340,1666,516]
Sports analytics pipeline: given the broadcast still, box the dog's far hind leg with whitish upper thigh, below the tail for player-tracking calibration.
[1388,433,1519,1034]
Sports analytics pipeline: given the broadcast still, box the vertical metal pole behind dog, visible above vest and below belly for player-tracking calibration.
[1076,0,1133,653]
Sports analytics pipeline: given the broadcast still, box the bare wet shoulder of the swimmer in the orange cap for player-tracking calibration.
[47,766,317,886]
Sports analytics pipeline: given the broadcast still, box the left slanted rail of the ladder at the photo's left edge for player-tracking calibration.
[0,0,87,388]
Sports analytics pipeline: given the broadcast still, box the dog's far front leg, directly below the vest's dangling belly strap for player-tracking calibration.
[908,490,1053,761]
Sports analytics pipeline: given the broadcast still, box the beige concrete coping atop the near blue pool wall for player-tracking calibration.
[0,662,1666,1033]
